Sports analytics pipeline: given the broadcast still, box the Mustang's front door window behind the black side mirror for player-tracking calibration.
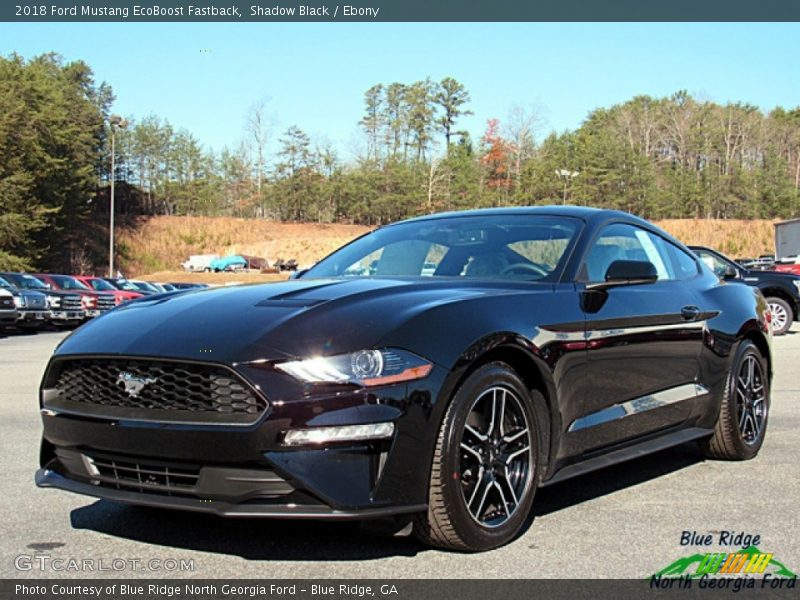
[581,223,675,282]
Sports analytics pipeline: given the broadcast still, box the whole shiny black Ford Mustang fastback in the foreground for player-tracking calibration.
[36,207,772,550]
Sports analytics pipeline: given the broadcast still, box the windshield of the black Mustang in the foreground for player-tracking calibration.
[305,215,580,281]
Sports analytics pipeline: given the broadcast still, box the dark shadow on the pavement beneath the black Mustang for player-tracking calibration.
[71,445,702,561]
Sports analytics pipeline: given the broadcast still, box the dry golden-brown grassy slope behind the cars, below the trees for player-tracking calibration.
[119,217,774,284]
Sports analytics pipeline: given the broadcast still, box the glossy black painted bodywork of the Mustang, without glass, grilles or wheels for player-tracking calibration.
[37,207,771,518]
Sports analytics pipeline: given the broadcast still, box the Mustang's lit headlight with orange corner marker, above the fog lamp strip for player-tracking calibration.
[275,349,433,386]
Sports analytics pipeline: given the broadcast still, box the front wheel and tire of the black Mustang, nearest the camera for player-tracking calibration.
[414,362,543,552]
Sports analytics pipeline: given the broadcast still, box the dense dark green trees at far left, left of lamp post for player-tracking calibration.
[0,54,112,269]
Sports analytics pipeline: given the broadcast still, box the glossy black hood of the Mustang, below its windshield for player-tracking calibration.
[57,278,552,364]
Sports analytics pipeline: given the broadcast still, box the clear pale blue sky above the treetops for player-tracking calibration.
[0,23,800,158]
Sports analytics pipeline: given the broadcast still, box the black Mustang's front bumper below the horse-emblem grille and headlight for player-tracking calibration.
[36,358,444,519]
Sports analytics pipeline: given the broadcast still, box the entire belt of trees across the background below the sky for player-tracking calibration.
[0,54,800,270]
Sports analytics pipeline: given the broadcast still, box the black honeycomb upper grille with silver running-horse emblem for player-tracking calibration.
[51,359,267,423]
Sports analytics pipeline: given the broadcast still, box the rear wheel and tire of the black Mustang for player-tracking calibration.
[701,340,769,460]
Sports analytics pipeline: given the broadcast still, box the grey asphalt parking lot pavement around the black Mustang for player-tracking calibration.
[0,324,800,578]
